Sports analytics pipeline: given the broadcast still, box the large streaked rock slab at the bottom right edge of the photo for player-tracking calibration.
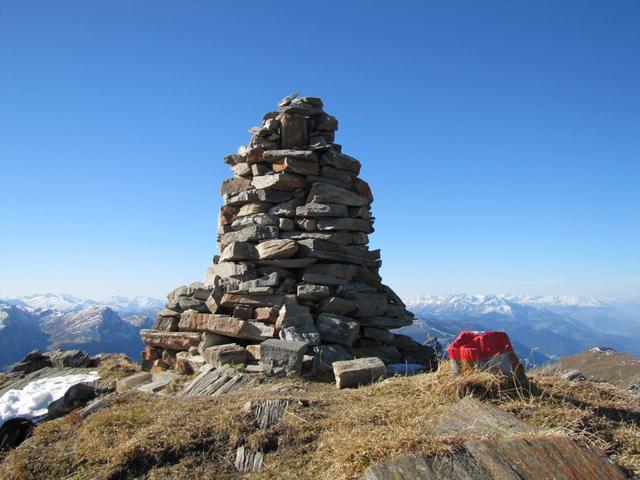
[363,435,628,480]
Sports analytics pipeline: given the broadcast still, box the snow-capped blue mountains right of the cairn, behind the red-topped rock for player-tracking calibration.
[403,294,640,364]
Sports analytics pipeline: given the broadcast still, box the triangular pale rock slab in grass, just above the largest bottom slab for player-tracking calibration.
[436,396,539,437]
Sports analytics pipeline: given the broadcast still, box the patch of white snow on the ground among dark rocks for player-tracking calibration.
[0,372,99,426]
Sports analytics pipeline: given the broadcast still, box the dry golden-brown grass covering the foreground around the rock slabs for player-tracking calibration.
[0,365,640,479]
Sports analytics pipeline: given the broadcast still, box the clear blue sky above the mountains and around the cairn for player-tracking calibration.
[0,0,640,297]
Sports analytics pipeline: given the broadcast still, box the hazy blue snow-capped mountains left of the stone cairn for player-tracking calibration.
[0,294,164,370]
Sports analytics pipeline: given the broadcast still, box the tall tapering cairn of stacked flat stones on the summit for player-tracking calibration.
[141,94,434,375]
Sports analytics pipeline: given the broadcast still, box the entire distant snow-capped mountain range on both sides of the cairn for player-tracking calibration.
[0,294,640,370]
